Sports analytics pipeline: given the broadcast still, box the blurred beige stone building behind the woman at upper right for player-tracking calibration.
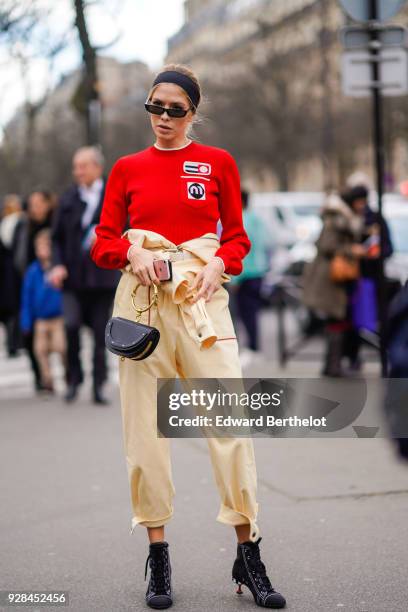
[167,0,408,190]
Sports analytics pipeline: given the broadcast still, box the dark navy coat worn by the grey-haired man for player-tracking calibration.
[52,181,120,291]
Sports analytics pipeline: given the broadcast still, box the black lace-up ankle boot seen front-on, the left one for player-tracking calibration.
[145,542,173,610]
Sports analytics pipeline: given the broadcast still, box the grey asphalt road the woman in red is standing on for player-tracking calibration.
[0,320,408,612]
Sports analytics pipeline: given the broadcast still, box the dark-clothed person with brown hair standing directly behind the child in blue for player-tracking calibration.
[14,188,55,393]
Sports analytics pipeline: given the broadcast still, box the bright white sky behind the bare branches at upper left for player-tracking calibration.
[0,0,184,137]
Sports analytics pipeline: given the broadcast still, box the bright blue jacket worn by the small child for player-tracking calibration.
[20,261,62,331]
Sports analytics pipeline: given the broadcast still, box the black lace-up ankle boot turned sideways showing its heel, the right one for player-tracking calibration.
[232,538,286,608]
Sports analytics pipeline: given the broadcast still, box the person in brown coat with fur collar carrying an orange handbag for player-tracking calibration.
[302,194,366,376]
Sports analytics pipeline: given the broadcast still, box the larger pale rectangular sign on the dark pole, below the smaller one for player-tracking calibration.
[342,48,408,98]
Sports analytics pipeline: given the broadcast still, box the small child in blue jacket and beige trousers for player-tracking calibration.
[21,229,66,393]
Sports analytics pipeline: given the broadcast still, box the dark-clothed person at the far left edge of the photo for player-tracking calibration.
[0,194,24,357]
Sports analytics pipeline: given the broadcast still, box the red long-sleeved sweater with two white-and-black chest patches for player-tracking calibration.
[91,142,251,274]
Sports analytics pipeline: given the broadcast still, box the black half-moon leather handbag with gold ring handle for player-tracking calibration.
[105,284,160,361]
